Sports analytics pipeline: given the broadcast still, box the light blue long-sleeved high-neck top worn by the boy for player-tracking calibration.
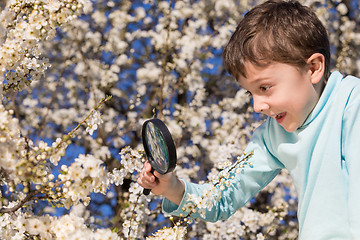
[163,72,360,240]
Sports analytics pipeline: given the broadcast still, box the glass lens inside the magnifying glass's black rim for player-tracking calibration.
[145,122,169,174]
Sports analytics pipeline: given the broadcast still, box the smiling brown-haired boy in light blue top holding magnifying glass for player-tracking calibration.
[138,0,360,240]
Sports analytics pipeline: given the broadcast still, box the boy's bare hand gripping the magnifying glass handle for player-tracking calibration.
[137,161,185,205]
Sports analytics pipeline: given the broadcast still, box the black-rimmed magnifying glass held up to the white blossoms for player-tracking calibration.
[142,118,176,195]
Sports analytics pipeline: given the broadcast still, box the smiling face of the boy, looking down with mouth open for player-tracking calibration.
[238,62,320,132]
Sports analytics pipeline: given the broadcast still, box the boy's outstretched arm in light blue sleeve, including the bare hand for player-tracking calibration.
[138,123,284,222]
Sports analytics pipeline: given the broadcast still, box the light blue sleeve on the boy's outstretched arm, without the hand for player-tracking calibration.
[162,122,284,222]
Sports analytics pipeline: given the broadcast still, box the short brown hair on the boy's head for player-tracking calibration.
[223,0,330,80]
